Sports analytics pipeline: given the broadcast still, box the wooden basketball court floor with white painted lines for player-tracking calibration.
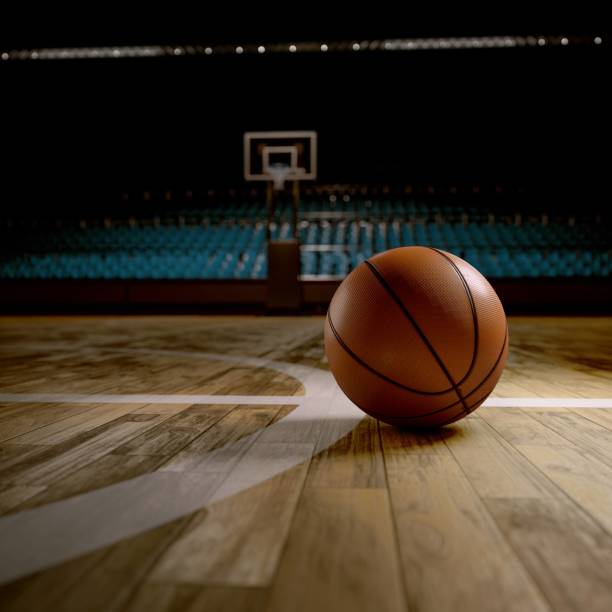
[0,316,612,612]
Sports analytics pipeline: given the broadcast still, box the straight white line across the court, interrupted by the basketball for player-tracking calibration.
[0,393,612,408]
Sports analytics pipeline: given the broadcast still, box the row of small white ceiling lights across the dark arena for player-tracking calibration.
[0,36,603,60]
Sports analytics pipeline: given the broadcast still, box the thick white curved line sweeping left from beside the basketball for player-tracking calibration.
[0,347,364,583]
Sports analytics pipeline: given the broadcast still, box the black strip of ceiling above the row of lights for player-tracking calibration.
[0,8,603,48]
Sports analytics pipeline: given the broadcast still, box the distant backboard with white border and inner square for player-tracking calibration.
[244,131,317,183]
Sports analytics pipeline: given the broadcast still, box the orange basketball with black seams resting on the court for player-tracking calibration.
[325,246,508,427]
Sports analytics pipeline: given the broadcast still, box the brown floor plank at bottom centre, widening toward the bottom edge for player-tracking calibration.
[265,488,406,612]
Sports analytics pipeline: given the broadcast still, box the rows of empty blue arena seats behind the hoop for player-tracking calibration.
[0,196,612,280]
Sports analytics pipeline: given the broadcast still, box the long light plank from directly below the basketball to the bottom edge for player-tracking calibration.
[383,435,548,611]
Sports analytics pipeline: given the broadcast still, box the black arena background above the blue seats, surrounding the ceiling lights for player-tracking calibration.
[0,15,609,210]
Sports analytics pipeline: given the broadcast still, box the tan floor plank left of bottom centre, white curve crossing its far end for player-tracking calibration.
[150,443,312,586]
